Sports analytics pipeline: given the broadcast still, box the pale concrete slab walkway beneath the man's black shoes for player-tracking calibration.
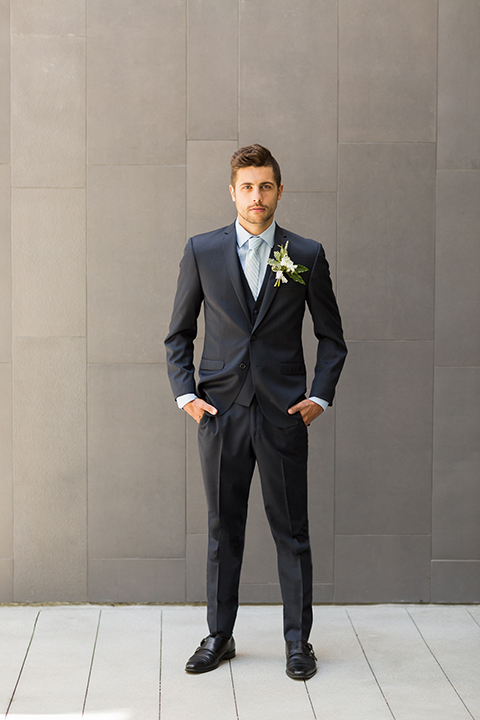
[0,605,480,720]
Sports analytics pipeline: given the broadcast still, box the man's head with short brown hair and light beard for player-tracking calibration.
[230,145,283,235]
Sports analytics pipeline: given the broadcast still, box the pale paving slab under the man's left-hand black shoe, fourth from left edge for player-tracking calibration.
[160,607,237,720]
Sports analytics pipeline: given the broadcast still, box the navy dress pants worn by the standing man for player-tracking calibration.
[198,398,312,641]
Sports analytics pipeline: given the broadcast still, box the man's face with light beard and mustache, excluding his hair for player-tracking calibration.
[230,167,283,235]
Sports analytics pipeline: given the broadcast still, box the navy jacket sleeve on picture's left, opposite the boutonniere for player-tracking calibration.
[165,239,203,398]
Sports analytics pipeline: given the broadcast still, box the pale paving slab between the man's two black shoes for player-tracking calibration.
[231,606,315,720]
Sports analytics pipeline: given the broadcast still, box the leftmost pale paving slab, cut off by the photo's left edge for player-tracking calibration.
[0,607,40,715]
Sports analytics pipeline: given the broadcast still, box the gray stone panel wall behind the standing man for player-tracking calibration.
[0,0,480,603]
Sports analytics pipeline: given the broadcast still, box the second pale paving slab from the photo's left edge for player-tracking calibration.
[8,607,99,718]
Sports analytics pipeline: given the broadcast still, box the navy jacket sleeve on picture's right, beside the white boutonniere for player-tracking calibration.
[307,240,347,405]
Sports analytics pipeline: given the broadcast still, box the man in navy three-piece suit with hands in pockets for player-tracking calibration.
[165,144,347,680]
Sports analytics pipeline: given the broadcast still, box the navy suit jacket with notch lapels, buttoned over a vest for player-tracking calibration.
[165,223,347,427]
